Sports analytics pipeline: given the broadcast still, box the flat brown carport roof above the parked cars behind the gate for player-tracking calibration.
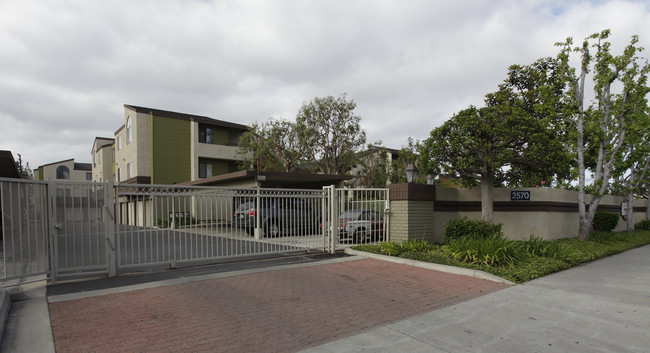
[181,170,352,188]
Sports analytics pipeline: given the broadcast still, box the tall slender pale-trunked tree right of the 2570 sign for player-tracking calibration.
[556,30,647,241]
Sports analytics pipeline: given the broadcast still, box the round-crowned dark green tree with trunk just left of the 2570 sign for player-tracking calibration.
[420,104,540,222]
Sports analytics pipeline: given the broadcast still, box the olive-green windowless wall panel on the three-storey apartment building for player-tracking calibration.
[151,116,192,184]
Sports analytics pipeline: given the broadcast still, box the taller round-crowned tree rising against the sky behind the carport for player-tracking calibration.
[296,94,366,174]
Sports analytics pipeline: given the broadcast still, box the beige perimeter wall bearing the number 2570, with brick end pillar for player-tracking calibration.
[390,187,646,242]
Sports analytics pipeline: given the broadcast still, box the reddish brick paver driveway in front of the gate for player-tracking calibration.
[49,259,507,352]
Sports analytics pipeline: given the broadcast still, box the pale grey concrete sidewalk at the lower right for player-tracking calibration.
[304,246,650,353]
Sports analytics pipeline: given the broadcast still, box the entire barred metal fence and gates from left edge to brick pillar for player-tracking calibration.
[0,178,389,281]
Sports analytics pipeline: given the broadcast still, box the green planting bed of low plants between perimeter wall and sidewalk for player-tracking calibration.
[353,219,650,283]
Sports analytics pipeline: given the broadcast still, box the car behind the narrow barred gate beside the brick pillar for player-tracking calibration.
[339,209,386,243]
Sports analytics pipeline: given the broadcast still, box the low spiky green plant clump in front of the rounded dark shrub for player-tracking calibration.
[445,235,523,266]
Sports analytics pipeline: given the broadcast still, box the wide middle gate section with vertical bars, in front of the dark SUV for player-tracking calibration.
[116,185,327,269]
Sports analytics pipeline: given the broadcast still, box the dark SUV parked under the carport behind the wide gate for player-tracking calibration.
[232,197,321,238]
